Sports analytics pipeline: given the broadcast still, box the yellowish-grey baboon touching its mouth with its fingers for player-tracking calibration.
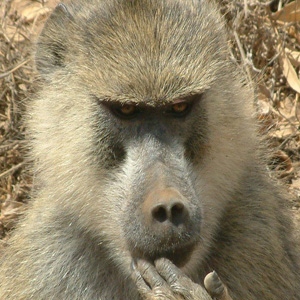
[0,0,300,300]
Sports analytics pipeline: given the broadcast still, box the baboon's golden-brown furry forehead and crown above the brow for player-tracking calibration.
[71,0,226,104]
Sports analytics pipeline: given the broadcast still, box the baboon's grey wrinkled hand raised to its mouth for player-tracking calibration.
[133,258,231,300]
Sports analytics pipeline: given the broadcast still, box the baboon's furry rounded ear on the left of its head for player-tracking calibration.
[35,4,73,77]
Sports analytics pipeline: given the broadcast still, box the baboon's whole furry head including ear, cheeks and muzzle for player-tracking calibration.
[29,0,255,273]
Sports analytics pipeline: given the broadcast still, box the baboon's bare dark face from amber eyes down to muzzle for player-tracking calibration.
[99,94,207,264]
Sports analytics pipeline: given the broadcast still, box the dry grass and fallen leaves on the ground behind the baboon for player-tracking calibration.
[0,0,300,242]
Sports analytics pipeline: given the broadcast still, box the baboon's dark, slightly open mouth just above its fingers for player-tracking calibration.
[134,244,194,268]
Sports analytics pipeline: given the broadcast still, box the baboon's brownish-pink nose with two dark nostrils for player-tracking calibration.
[143,188,189,229]
